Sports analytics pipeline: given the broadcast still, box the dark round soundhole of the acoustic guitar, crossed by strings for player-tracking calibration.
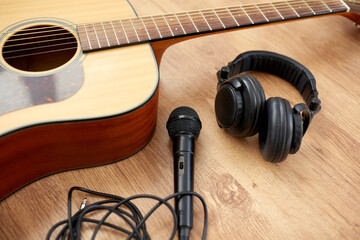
[2,25,78,72]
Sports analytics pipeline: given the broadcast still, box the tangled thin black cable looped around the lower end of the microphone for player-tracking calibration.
[46,187,208,240]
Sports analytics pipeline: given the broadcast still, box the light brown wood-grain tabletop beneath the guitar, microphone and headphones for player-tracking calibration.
[0,0,360,239]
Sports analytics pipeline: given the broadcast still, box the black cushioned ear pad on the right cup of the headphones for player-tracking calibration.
[259,97,294,163]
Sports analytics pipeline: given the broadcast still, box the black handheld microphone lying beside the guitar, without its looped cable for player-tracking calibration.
[166,107,201,240]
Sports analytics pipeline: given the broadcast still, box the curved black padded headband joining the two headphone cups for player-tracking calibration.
[217,51,321,117]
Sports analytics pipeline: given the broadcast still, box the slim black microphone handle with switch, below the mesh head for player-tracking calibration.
[173,134,195,239]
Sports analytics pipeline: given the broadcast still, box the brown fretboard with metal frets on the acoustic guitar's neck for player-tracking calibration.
[77,0,349,52]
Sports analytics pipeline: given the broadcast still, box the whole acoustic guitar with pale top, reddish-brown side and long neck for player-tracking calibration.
[0,0,360,199]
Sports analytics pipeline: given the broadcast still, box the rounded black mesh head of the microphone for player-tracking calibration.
[166,107,201,138]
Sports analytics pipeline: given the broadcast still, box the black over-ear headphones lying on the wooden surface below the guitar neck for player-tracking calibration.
[215,51,321,163]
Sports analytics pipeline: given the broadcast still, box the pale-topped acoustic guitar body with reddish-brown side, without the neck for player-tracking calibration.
[0,0,159,199]
